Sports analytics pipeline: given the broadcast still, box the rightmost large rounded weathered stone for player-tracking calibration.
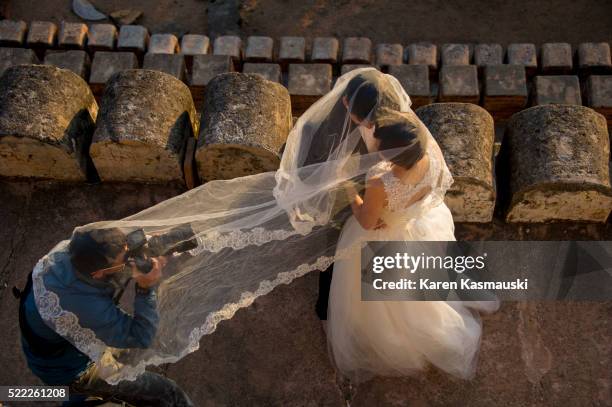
[500,105,612,223]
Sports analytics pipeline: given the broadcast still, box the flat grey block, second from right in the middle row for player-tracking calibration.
[533,75,582,105]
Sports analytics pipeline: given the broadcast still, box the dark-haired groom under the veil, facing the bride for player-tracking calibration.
[304,70,400,321]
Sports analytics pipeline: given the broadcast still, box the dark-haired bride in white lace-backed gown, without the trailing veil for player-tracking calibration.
[327,111,495,382]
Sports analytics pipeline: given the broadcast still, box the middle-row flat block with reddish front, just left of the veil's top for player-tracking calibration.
[288,64,332,114]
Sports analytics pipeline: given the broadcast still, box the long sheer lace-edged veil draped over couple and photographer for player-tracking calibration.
[33,68,452,383]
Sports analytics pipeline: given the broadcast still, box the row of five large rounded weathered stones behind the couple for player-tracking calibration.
[0,65,612,222]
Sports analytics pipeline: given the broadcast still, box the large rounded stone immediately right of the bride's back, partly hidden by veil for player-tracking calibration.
[416,103,496,222]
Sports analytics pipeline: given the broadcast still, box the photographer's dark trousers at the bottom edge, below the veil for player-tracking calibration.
[65,364,193,407]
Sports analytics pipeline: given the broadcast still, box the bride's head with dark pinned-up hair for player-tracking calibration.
[374,111,427,169]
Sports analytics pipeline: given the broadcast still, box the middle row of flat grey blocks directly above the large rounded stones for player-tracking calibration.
[0,48,612,122]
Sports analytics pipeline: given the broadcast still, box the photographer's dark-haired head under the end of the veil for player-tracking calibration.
[68,228,126,276]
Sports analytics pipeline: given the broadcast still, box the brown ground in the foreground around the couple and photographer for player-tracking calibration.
[0,181,612,406]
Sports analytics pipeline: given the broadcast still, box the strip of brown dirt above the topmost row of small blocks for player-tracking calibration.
[4,0,612,45]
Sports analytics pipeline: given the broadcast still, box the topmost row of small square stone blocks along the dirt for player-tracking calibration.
[0,20,612,74]
